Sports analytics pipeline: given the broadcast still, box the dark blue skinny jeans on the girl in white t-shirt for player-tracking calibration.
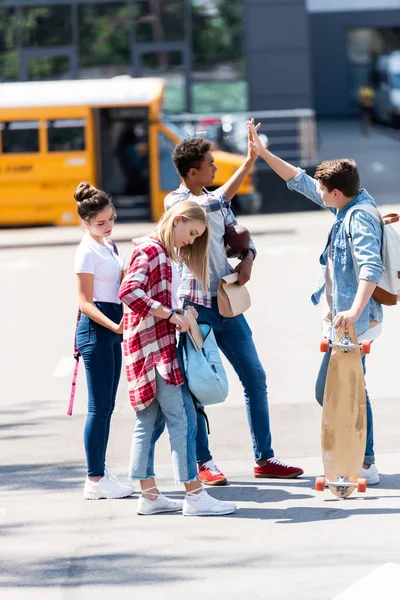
[76,302,122,477]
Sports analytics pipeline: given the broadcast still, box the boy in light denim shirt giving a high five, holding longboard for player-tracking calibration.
[248,123,384,485]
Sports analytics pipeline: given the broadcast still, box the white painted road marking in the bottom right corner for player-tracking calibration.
[332,563,400,600]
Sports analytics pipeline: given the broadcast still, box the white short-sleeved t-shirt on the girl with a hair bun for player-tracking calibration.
[75,233,123,304]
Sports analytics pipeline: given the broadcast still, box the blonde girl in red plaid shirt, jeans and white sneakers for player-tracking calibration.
[119,201,236,516]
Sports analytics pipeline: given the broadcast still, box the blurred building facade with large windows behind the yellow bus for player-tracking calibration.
[0,0,312,112]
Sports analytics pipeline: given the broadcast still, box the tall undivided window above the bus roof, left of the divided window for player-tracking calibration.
[79,4,131,78]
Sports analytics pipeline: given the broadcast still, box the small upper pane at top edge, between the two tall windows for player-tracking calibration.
[134,0,185,42]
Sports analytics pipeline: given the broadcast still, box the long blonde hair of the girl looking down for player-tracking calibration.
[157,200,210,296]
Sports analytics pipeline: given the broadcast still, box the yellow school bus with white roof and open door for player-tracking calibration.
[0,76,258,226]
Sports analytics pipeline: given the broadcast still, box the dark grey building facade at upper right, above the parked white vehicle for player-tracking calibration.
[307,0,400,116]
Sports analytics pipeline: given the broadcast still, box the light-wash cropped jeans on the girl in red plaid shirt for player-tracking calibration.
[129,349,198,483]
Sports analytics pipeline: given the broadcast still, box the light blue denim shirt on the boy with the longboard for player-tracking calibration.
[287,170,384,337]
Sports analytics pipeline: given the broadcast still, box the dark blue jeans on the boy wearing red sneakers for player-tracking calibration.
[186,298,274,464]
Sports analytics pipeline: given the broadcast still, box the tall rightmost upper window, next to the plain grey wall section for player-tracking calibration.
[192,0,245,81]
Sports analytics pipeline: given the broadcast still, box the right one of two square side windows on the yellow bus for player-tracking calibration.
[47,119,85,152]
